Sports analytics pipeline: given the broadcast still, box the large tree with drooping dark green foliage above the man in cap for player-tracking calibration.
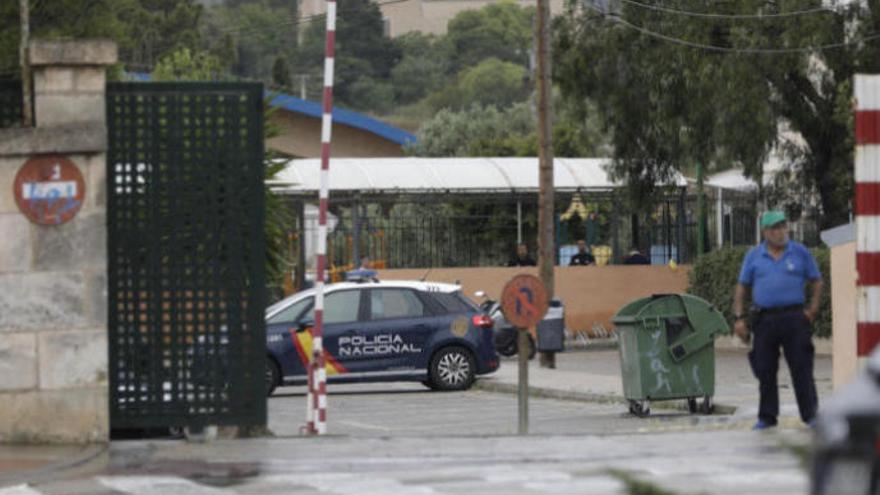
[554,0,880,226]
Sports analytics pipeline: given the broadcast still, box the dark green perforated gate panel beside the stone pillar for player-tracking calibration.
[107,83,266,429]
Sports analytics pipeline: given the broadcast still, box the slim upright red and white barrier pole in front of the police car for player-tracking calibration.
[306,0,336,435]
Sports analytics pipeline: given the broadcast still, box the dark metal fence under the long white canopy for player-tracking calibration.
[292,189,818,269]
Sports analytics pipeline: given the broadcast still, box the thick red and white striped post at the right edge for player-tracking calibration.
[855,74,880,364]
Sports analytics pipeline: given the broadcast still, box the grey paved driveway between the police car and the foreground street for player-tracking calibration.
[269,383,744,436]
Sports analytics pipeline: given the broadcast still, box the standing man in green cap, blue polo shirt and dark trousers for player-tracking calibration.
[733,211,822,430]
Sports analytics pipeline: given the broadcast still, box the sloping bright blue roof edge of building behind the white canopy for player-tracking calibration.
[128,72,416,146]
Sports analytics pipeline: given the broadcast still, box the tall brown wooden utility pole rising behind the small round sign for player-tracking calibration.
[532,0,556,368]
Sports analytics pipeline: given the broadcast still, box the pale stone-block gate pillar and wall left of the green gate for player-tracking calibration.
[0,41,116,443]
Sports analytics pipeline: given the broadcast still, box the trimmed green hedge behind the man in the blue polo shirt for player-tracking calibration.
[688,247,831,337]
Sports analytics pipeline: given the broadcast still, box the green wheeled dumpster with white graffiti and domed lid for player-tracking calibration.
[611,294,728,416]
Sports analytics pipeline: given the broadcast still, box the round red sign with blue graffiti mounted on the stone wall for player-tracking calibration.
[12,155,86,225]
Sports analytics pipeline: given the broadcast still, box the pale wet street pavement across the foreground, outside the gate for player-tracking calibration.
[0,430,808,495]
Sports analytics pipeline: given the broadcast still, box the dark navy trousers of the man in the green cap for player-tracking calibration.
[749,310,819,424]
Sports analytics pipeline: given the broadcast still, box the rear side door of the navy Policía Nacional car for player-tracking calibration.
[339,288,431,379]
